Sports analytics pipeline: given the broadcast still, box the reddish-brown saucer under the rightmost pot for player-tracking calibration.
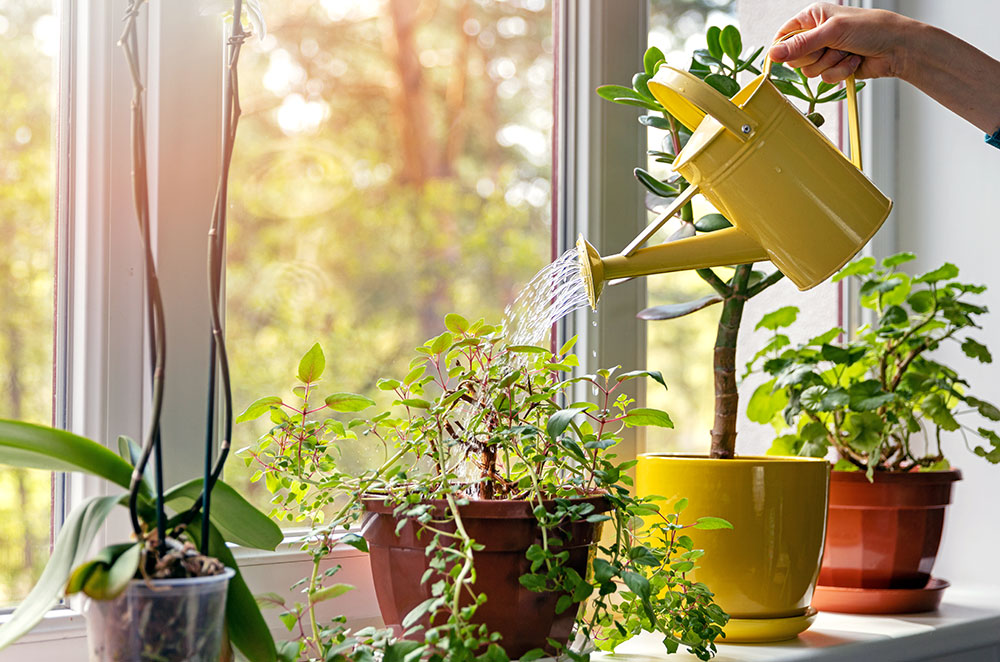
[812,577,951,614]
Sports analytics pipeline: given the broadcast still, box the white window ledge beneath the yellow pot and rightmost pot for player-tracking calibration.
[594,587,1000,662]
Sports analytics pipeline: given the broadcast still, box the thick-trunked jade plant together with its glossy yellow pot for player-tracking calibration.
[597,26,862,641]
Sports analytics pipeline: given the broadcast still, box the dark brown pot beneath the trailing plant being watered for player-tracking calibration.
[364,496,610,659]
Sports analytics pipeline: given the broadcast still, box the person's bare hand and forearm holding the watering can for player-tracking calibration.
[771,3,1000,133]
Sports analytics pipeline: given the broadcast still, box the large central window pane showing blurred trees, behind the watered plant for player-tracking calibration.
[226,0,554,520]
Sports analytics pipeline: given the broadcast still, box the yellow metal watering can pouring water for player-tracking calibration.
[577,33,892,309]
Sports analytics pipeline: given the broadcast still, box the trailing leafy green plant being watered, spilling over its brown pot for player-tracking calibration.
[238,314,729,661]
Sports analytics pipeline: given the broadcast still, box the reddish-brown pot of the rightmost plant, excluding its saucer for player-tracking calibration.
[819,470,962,589]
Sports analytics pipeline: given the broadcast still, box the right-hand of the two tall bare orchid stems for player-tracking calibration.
[199,0,248,555]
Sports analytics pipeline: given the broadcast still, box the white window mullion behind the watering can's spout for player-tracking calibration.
[556,0,648,456]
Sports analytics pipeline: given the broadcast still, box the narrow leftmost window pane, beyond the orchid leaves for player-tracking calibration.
[0,0,59,608]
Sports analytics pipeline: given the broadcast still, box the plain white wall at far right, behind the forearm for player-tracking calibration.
[896,0,1000,584]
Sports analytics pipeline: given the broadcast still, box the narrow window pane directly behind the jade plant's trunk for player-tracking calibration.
[637,0,737,452]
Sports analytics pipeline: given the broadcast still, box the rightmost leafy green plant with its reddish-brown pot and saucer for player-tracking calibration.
[748,253,1000,613]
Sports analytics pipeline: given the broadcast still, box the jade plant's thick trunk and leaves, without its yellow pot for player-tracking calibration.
[597,25,864,458]
